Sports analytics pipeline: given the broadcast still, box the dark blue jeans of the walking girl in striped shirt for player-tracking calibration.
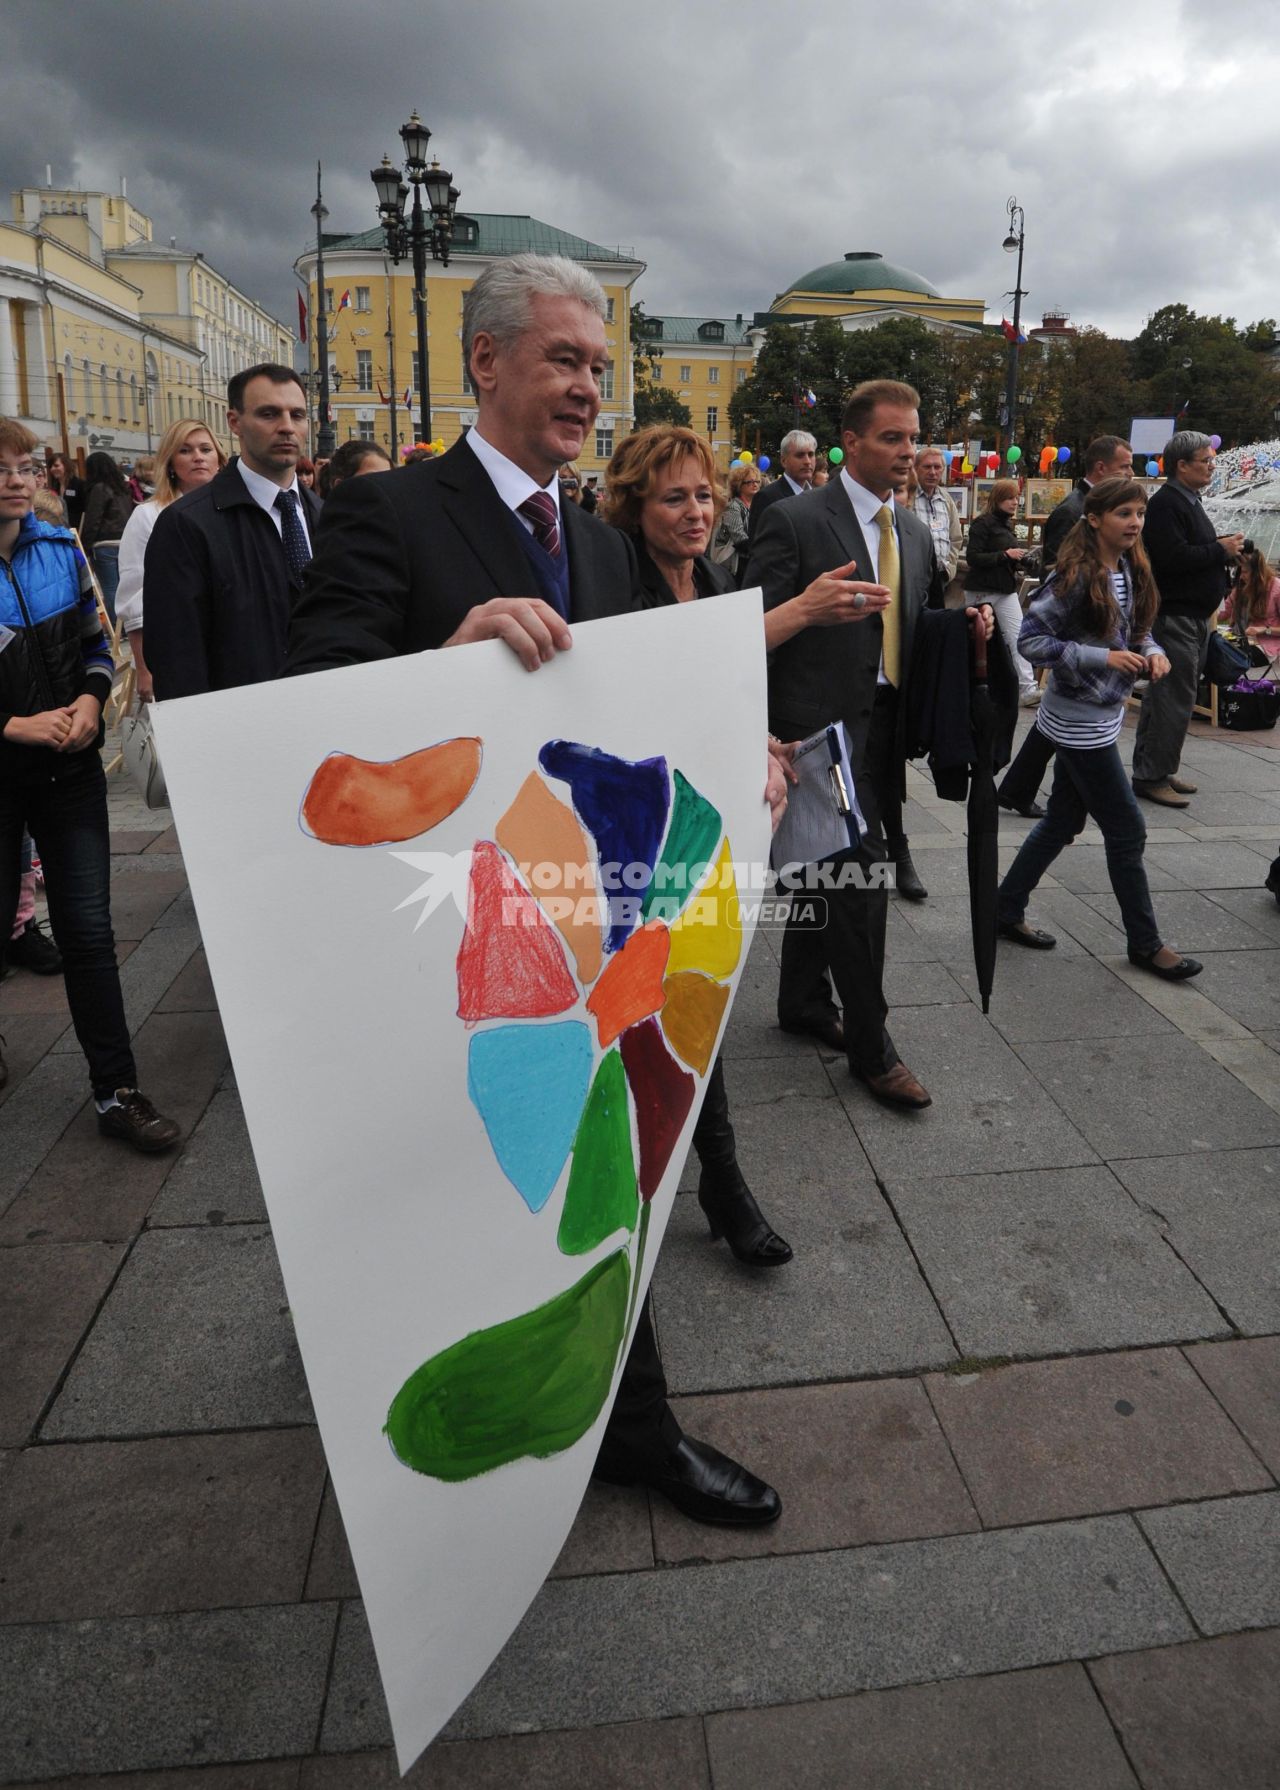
[995,745,1160,958]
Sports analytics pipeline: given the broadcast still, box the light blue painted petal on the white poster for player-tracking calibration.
[467,1020,593,1212]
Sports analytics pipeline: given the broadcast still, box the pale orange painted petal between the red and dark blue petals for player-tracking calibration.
[494,771,605,988]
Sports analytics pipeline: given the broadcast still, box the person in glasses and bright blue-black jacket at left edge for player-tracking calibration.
[0,417,179,1151]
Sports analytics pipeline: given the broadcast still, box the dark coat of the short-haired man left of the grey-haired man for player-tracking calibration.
[143,458,320,698]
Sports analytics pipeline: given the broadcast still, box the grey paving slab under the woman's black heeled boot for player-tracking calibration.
[653,1101,954,1393]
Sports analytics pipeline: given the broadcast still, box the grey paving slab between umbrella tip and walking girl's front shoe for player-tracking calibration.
[956,945,1174,1044]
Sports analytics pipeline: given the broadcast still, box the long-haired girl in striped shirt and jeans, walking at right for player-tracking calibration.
[997,478,1203,981]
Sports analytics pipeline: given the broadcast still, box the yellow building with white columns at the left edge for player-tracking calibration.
[0,186,294,460]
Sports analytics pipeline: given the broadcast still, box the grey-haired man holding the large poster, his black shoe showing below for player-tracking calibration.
[288,254,782,1525]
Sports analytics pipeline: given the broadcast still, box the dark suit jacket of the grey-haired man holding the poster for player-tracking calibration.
[286,440,639,673]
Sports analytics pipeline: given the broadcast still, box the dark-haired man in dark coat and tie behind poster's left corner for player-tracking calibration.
[143,363,320,700]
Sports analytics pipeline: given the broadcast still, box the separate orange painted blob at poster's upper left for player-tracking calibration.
[303,739,482,845]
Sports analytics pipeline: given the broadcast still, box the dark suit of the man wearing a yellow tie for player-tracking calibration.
[745,478,938,1076]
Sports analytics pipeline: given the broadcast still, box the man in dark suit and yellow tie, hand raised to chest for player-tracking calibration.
[745,379,992,1108]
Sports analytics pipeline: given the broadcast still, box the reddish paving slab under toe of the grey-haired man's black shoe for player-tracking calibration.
[651,1380,979,1563]
